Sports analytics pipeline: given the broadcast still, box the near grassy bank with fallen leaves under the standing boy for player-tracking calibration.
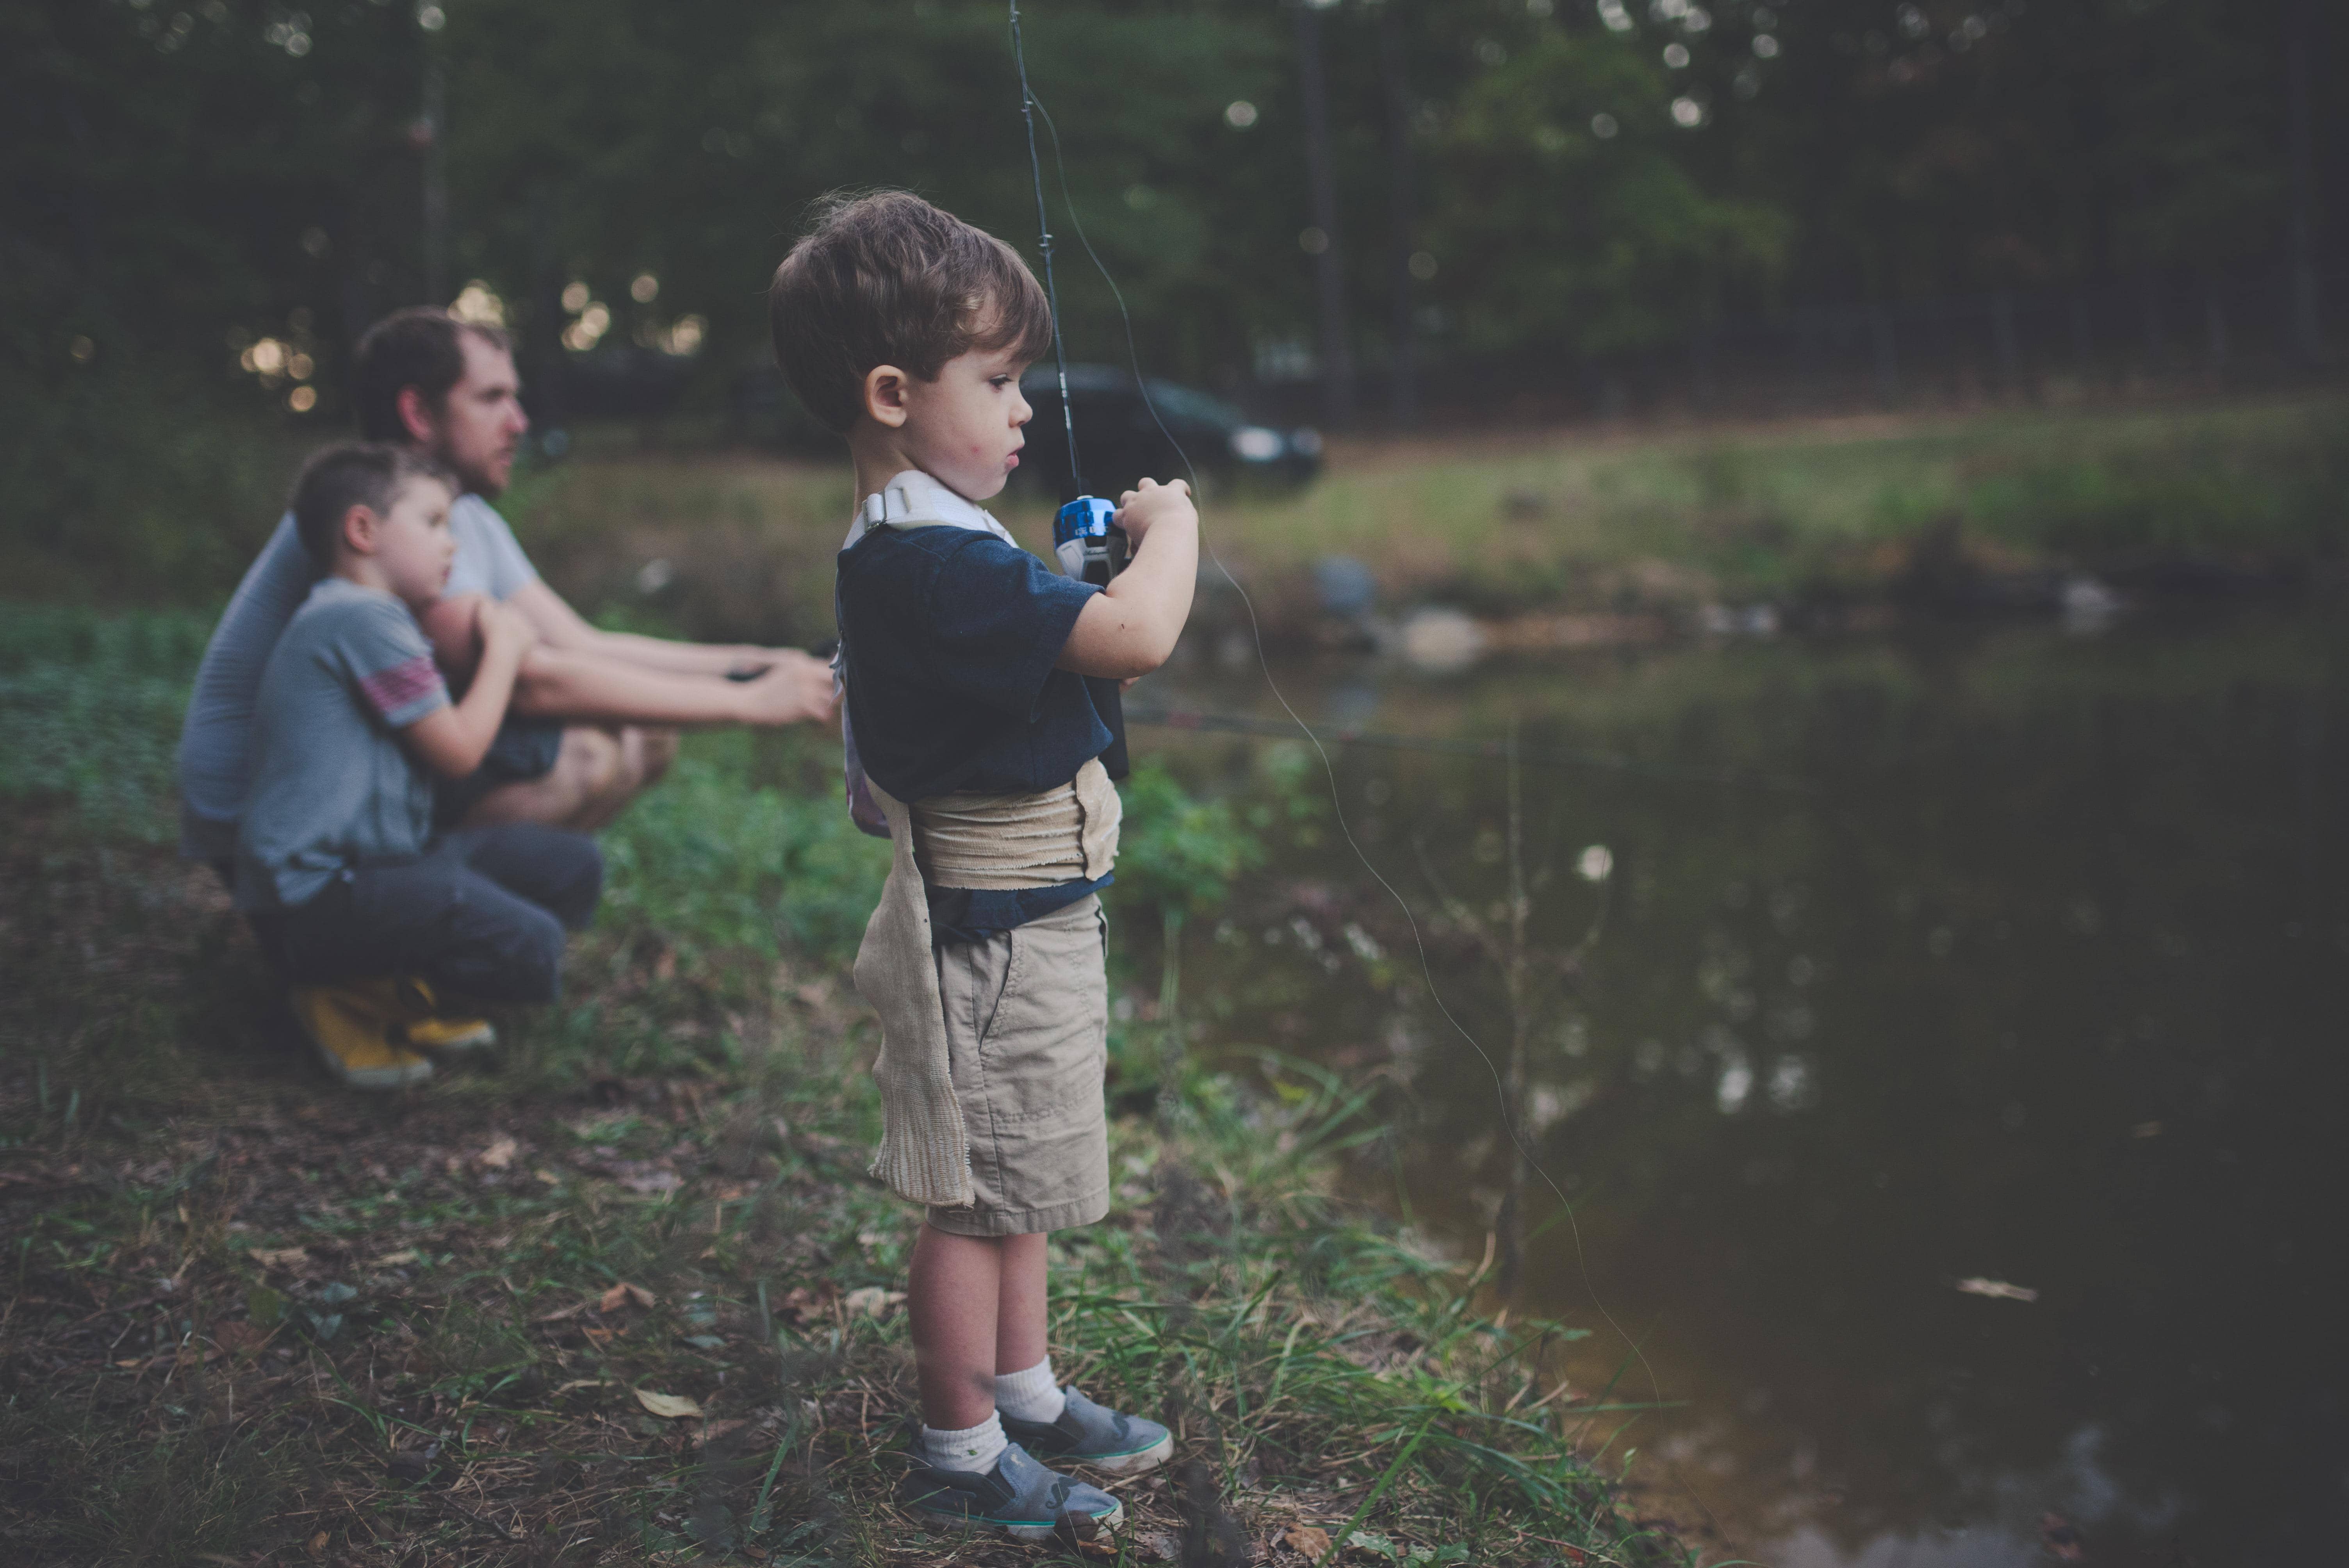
[0,613,1677,1566]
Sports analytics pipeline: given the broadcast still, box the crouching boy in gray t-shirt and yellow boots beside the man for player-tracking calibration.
[235,444,604,1089]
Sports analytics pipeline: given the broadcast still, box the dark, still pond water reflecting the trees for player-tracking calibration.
[1132,610,2349,1568]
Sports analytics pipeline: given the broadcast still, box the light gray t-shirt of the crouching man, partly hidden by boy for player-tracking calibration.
[178,495,538,859]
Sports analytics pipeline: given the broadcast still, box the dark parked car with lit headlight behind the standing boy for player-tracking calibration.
[1019,362,1320,500]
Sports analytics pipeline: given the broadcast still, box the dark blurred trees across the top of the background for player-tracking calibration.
[0,0,2349,596]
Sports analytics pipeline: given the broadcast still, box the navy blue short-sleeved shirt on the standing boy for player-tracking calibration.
[839,526,1111,800]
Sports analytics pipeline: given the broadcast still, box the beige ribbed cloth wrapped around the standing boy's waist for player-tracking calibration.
[907,761,1121,892]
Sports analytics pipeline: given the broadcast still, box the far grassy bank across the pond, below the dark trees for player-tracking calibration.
[486,397,2349,638]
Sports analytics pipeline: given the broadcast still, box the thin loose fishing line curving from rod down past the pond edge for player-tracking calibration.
[1010,12,1663,1404]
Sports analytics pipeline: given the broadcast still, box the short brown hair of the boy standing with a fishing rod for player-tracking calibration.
[766,190,1052,434]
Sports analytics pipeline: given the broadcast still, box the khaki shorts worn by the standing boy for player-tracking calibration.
[928,894,1109,1237]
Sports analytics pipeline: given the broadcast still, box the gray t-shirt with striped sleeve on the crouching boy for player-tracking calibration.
[237,577,449,909]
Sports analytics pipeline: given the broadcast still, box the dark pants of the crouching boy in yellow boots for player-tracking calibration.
[254,821,604,1002]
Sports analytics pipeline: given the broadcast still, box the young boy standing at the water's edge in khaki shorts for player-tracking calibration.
[770,192,1198,1540]
